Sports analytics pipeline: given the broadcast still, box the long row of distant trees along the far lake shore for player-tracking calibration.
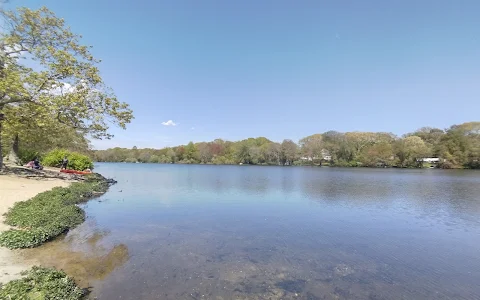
[94,122,480,169]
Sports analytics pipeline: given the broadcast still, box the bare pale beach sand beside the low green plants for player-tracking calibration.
[0,175,70,283]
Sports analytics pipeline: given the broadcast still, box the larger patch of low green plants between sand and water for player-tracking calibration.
[0,174,109,249]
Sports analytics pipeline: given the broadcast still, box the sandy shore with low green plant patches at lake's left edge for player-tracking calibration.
[0,167,116,300]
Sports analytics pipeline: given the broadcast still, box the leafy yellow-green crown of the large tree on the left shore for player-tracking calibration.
[0,7,133,167]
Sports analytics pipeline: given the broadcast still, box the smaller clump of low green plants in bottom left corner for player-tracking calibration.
[0,267,86,300]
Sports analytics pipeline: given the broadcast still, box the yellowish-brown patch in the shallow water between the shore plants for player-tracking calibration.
[26,232,129,287]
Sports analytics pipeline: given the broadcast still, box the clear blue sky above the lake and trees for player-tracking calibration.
[10,0,480,149]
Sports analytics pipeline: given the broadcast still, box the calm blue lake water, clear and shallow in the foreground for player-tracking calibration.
[28,164,480,300]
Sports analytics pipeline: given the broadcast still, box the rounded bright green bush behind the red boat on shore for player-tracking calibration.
[42,149,93,171]
